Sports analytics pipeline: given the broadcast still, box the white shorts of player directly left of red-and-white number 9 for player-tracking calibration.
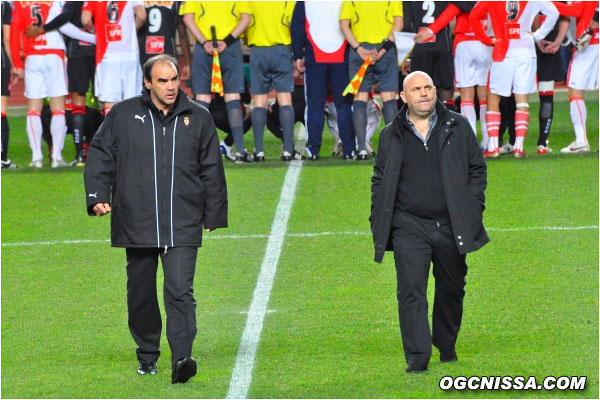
[454,40,492,88]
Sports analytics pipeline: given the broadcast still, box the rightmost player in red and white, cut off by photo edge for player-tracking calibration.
[555,1,598,154]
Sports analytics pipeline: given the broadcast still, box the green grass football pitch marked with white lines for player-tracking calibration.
[0,93,599,398]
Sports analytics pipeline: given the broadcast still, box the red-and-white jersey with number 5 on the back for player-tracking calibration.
[10,1,65,69]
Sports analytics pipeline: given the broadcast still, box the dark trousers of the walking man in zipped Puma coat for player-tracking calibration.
[126,247,198,363]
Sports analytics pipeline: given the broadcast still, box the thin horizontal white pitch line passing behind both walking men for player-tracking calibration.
[2,225,598,247]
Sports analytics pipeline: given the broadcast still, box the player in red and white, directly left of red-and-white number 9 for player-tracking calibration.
[415,1,492,148]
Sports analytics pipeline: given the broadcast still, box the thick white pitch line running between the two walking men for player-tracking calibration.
[226,161,302,399]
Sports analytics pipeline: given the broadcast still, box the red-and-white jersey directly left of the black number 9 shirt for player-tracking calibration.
[83,1,144,64]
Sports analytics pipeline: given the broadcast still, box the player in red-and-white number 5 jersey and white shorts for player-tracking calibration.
[11,1,84,168]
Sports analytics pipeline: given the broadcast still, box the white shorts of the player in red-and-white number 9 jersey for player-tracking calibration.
[490,57,537,97]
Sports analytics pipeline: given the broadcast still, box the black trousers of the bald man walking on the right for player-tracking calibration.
[392,211,467,365]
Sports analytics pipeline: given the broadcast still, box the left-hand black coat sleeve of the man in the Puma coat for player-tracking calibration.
[83,111,117,216]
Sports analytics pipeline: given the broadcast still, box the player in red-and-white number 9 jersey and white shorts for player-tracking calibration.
[469,1,558,158]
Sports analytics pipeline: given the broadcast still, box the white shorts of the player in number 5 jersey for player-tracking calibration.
[25,54,68,99]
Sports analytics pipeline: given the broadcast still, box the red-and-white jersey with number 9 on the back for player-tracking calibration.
[469,1,558,61]
